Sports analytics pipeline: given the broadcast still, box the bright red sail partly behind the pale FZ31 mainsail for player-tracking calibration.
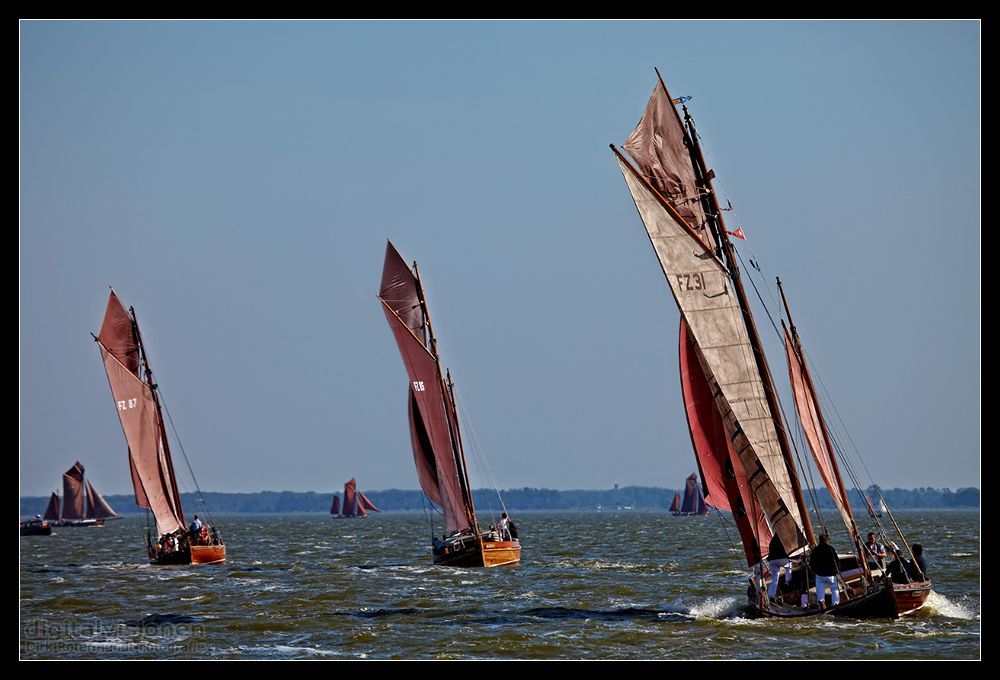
[680,318,771,566]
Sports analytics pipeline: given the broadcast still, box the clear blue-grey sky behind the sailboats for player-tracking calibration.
[18,21,982,495]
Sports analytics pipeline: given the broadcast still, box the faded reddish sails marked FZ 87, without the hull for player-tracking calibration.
[97,291,185,534]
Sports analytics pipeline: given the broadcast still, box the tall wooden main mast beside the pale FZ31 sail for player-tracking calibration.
[676,97,816,549]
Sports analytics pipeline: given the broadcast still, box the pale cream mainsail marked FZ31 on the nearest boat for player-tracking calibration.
[616,152,805,550]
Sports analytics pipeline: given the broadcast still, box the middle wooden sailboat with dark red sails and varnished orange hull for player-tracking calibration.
[379,243,521,567]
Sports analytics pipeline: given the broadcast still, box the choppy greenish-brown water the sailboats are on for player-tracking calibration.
[20,511,981,660]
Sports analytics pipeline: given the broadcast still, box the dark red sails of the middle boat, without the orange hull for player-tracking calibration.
[379,243,472,533]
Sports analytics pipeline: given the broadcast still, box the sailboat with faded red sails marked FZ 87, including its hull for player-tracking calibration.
[94,290,226,564]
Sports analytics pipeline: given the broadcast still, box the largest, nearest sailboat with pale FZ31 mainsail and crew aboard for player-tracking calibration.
[611,72,931,618]
